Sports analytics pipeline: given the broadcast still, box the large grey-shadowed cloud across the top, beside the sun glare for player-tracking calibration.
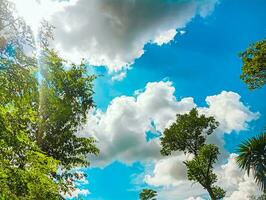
[51,0,217,72]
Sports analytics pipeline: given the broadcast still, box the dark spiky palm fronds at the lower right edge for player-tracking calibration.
[237,132,266,193]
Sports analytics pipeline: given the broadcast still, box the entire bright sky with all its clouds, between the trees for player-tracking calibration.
[13,0,266,200]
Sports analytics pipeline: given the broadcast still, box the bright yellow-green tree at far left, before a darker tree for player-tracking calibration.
[0,57,61,200]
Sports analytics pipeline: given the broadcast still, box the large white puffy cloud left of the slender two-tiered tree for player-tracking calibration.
[79,81,195,166]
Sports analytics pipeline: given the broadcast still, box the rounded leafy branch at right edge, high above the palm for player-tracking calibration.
[240,40,266,90]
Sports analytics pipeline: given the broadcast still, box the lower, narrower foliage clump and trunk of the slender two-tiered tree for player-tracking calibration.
[184,144,225,199]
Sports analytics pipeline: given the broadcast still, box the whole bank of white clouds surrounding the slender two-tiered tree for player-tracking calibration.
[78,81,259,200]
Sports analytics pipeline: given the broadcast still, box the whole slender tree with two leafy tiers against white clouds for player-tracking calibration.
[160,108,225,200]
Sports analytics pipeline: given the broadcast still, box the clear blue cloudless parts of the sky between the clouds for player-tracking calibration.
[64,0,266,200]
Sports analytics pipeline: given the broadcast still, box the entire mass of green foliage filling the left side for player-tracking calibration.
[0,47,98,200]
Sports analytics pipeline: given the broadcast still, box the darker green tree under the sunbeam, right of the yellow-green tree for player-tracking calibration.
[37,51,98,168]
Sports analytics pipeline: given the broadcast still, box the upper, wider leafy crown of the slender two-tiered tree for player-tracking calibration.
[160,108,218,155]
